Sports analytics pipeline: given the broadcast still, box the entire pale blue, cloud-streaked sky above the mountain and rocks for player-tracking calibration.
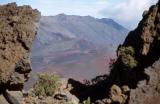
[0,0,158,30]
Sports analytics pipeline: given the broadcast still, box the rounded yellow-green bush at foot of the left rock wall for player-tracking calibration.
[33,73,60,96]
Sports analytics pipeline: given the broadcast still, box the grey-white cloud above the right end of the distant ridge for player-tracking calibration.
[99,0,158,29]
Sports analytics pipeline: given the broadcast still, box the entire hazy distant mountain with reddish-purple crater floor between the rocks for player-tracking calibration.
[31,14,128,77]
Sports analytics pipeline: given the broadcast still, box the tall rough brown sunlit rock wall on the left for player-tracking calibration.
[0,3,40,92]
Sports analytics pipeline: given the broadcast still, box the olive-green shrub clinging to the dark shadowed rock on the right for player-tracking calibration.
[118,46,137,69]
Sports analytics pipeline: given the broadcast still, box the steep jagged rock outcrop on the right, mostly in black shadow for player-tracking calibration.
[107,1,160,104]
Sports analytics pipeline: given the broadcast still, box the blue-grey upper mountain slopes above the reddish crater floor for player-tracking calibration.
[35,14,128,44]
